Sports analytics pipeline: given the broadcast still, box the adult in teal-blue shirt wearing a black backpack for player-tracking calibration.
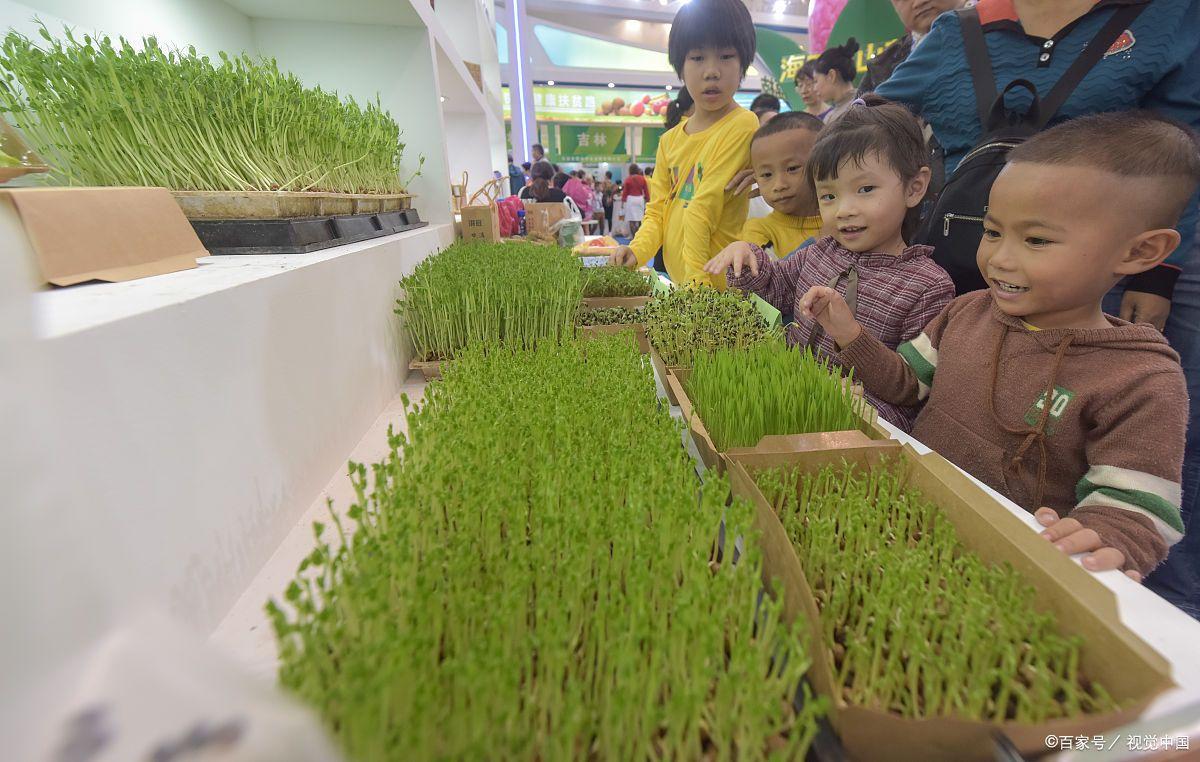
[876,0,1200,618]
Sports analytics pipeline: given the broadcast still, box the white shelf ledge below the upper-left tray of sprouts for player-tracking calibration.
[29,224,454,650]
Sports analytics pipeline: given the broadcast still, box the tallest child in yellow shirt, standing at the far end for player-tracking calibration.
[611,0,758,289]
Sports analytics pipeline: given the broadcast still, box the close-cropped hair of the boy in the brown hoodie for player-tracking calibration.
[1008,112,1200,228]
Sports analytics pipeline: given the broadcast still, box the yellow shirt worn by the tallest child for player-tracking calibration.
[630,107,758,289]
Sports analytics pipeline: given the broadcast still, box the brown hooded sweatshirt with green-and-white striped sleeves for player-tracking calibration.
[840,292,1188,574]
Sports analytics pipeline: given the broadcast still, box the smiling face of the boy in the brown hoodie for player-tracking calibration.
[976,162,1146,328]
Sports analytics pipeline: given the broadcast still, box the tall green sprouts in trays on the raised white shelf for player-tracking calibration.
[0,25,410,193]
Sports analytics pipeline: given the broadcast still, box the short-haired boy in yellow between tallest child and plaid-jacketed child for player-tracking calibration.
[722,112,823,258]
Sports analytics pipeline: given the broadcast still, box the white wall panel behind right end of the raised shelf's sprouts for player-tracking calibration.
[252,19,453,222]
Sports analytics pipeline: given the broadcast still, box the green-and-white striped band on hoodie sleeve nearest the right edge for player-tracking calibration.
[1075,466,1183,546]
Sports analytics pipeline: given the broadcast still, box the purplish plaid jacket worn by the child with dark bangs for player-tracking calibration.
[727,236,954,431]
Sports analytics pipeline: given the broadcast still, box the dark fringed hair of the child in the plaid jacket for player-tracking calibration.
[806,95,929,186]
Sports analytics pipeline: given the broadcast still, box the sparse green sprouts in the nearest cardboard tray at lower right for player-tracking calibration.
[756,463,1117,722]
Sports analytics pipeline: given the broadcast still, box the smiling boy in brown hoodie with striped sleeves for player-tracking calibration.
[802,113,1200,580]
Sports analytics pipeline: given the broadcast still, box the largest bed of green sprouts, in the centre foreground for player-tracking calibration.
[268,336,823,762]
